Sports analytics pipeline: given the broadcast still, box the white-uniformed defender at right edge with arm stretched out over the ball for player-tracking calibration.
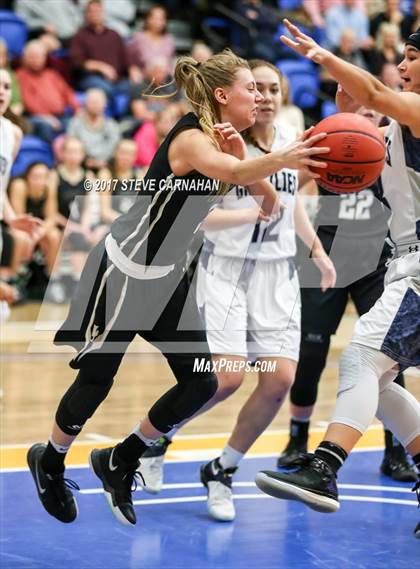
[256,20,420,537]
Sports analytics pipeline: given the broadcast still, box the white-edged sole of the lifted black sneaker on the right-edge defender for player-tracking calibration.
[255,472,340,514]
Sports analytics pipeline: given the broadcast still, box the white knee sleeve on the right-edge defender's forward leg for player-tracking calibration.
[331,343,395,433]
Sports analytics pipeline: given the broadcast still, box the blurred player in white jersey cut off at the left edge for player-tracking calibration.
[0,69,38,310]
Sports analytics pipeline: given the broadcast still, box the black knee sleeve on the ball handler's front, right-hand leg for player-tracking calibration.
[149,355,218,433]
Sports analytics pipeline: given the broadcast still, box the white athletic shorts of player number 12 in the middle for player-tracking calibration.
[197,253,301,361]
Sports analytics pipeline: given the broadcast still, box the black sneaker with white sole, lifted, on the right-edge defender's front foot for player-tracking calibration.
[255,453,340,513]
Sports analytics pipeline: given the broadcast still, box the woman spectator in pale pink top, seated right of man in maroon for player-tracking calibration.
[128,5,175,83]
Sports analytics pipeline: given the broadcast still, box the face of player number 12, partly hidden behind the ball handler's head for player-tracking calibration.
[252,66,282,124]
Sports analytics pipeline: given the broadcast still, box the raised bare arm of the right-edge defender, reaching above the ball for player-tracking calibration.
[281,20,419,130]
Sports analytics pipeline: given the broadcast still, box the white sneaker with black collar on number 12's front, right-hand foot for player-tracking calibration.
[200,458,238,522]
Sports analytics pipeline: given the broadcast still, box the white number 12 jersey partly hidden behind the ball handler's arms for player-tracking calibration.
[205,124,298,261]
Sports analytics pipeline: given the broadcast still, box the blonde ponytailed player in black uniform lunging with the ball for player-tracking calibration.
[28,50,329,525]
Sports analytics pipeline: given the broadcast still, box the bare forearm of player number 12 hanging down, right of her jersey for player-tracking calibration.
[294,194,337,292]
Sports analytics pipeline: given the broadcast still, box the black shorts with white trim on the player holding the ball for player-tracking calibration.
[54,239,210,371]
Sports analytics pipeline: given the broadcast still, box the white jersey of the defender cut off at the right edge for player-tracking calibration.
[381,120,420,246]
